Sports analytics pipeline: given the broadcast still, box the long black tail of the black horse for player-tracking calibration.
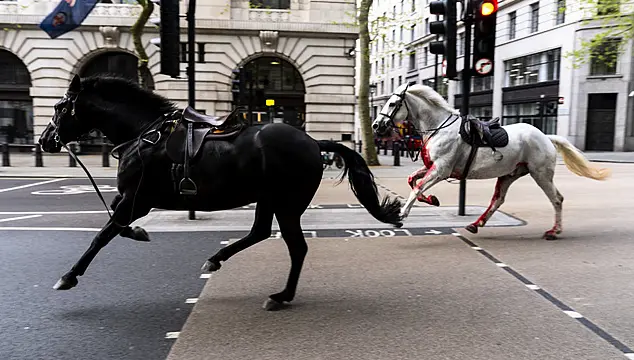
[317,140,403,227]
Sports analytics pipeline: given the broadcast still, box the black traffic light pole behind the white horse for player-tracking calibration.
[458,0,473,216]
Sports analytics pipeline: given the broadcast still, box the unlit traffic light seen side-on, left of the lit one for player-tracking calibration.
[429,0,458,79]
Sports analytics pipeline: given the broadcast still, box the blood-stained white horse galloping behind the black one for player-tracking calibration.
[372,84,610,240]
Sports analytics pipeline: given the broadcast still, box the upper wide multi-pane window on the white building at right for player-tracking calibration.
[504,49,561,86]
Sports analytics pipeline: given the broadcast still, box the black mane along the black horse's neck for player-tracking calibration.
[81,73,177,113]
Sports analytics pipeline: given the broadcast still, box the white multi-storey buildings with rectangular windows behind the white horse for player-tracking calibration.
[362,0,634,151]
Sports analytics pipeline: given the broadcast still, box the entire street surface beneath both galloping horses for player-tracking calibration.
[0,148,634,360]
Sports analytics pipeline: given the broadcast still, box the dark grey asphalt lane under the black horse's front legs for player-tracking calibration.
[0,179,226,360]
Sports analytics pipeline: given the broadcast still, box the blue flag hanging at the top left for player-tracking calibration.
[40,0,99,39]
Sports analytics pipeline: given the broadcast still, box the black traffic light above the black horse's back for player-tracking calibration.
[150,0,180,78]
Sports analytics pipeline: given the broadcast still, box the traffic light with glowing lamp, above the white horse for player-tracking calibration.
[473,0,498,76]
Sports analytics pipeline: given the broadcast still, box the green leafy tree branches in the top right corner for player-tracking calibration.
[559,0,634,68]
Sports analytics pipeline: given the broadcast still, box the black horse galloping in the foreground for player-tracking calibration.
[39,75,402,307]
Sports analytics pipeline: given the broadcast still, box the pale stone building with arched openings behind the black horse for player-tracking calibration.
[0,0,358,148]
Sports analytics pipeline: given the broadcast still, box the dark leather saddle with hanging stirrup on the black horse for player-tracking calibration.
[165,106,247,195]
